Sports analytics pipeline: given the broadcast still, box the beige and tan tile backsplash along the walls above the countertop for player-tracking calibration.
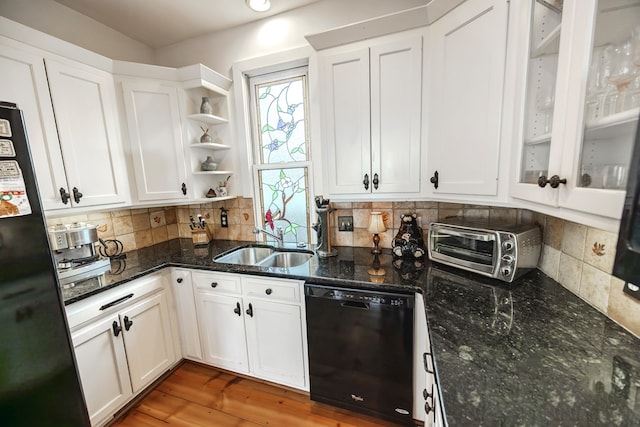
[47,197,640,337]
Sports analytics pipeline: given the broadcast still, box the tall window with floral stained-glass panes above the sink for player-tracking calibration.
[249,67,311,243]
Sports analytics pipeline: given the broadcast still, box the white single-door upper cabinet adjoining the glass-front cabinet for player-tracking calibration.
[422,0,509,197]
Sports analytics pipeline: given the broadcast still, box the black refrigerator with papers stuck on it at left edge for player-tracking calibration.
[0,102,90,427]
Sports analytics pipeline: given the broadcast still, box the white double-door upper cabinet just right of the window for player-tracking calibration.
[320,35,422,195]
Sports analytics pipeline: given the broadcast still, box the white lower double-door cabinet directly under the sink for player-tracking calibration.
[192,272,309,390]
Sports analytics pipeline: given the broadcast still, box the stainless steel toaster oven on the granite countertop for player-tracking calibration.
[427,218,542,282]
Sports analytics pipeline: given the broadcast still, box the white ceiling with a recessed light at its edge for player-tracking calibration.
[55,0,319,48]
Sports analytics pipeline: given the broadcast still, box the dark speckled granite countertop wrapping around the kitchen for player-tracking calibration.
[63,239,640,426]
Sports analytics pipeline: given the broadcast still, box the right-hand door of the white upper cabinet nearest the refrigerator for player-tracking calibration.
[44,58,129,211]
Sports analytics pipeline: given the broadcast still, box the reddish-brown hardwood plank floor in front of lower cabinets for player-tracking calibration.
[111,361,396,427]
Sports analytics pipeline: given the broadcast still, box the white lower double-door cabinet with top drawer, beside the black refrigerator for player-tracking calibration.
[66,275,177,426]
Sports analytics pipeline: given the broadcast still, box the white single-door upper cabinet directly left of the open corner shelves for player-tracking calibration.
[122,80,188,202]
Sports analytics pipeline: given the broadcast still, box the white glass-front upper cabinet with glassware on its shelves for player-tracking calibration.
[511,0,640,226]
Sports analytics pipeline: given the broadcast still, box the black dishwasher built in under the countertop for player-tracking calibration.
[305,284,414,424]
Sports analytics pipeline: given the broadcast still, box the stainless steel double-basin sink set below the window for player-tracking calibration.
[213,245,313,268]
